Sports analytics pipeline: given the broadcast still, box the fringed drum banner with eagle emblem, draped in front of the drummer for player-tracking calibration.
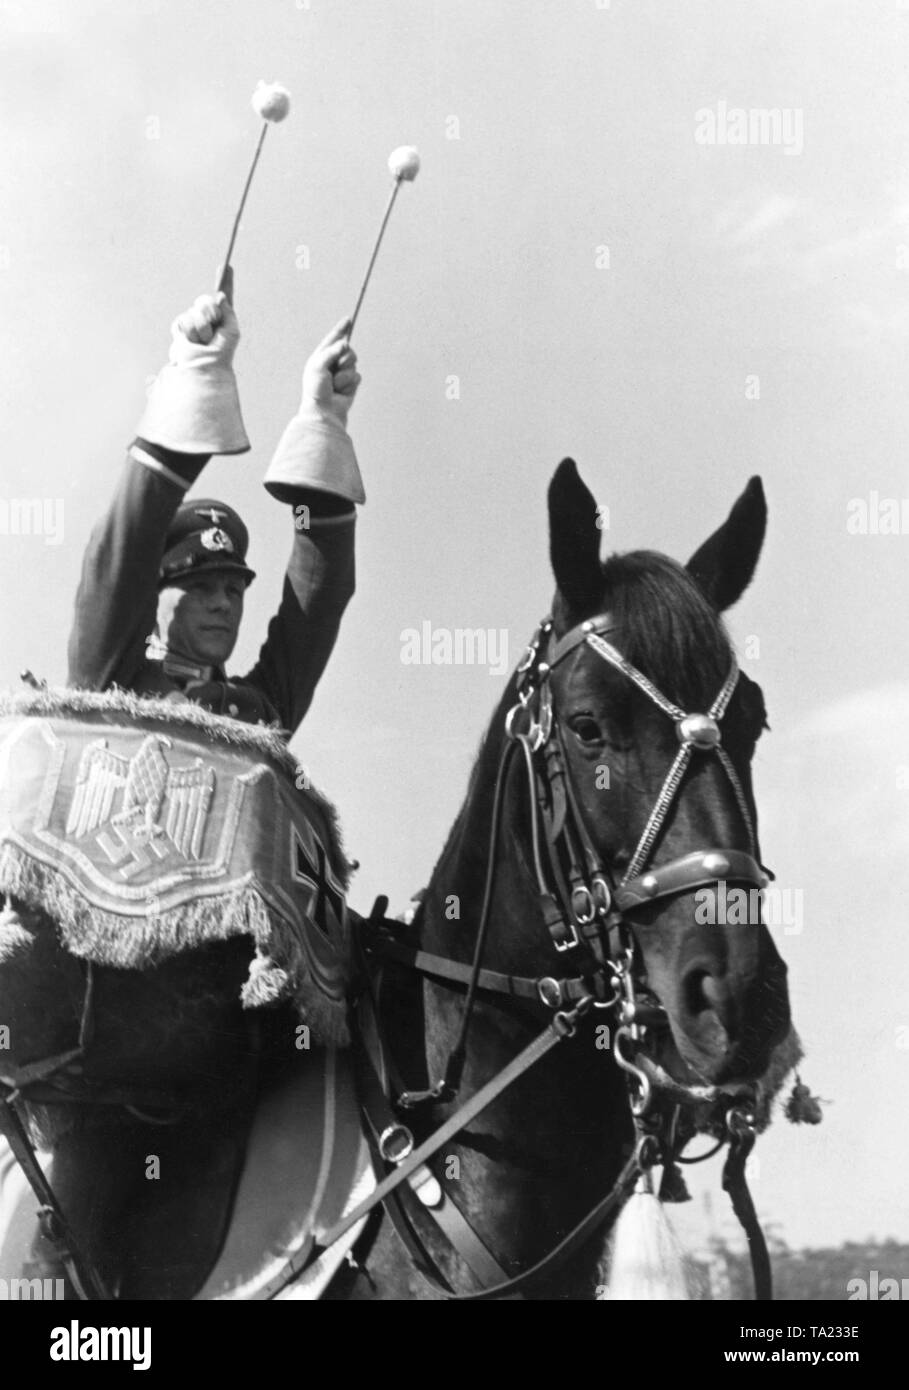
[0,691,350,1043]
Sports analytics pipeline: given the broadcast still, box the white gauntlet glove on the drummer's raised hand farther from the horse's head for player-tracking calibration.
[136,272,249,453]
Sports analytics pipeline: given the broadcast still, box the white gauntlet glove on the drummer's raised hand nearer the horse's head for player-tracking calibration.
[265,318,366,502]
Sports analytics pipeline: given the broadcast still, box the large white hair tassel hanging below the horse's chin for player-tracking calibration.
[598,1172,692,1302]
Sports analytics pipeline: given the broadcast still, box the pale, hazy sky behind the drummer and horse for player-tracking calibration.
[0,0,909,1256]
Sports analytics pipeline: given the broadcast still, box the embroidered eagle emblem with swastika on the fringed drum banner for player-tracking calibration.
[67,734,214,873]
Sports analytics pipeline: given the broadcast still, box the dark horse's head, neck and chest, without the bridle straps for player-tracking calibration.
[323,460,799,1300]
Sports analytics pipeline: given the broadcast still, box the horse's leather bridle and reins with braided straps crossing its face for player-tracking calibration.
[341,613,771,1298]
